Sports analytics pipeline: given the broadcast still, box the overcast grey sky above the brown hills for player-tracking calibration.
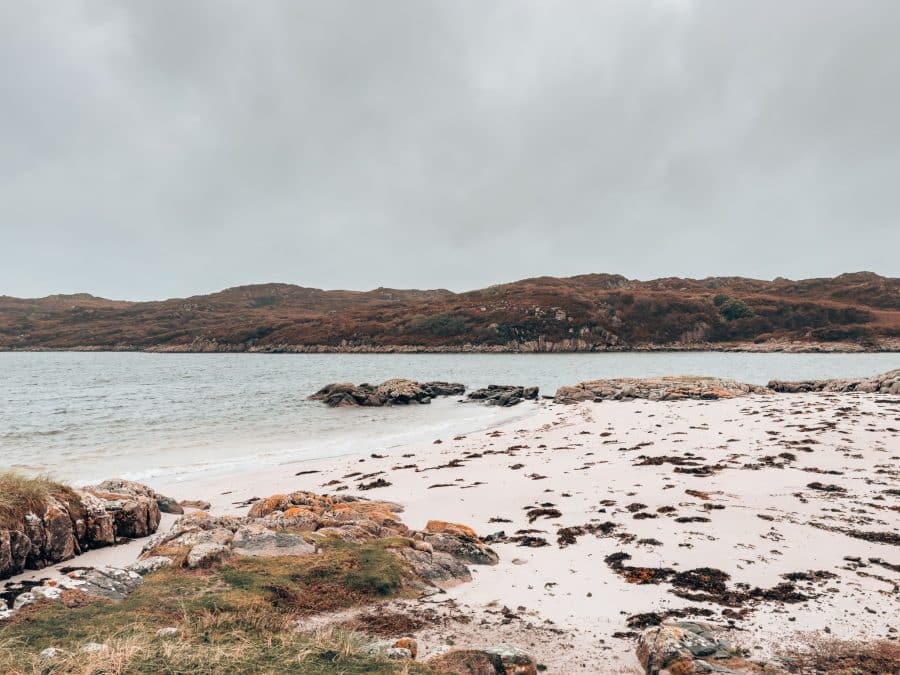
[0,0,900,299]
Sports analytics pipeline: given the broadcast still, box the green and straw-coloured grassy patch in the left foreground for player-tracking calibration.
[0,542,428,674]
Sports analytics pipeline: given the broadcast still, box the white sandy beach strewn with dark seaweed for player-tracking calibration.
[15,393,900,673]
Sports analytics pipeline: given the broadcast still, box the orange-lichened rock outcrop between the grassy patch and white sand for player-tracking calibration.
[142,491,498,590]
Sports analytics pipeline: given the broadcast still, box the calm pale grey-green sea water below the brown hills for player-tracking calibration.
[0,352,900,481]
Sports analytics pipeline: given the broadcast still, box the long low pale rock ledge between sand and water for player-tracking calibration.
[554,376,770,403]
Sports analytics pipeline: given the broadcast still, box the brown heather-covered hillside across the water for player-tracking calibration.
[0,272,900,351]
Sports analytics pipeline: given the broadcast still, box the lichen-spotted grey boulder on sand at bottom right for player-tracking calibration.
[637,621,786,675]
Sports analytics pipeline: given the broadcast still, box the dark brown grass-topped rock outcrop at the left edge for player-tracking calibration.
[0,481,160,579]
